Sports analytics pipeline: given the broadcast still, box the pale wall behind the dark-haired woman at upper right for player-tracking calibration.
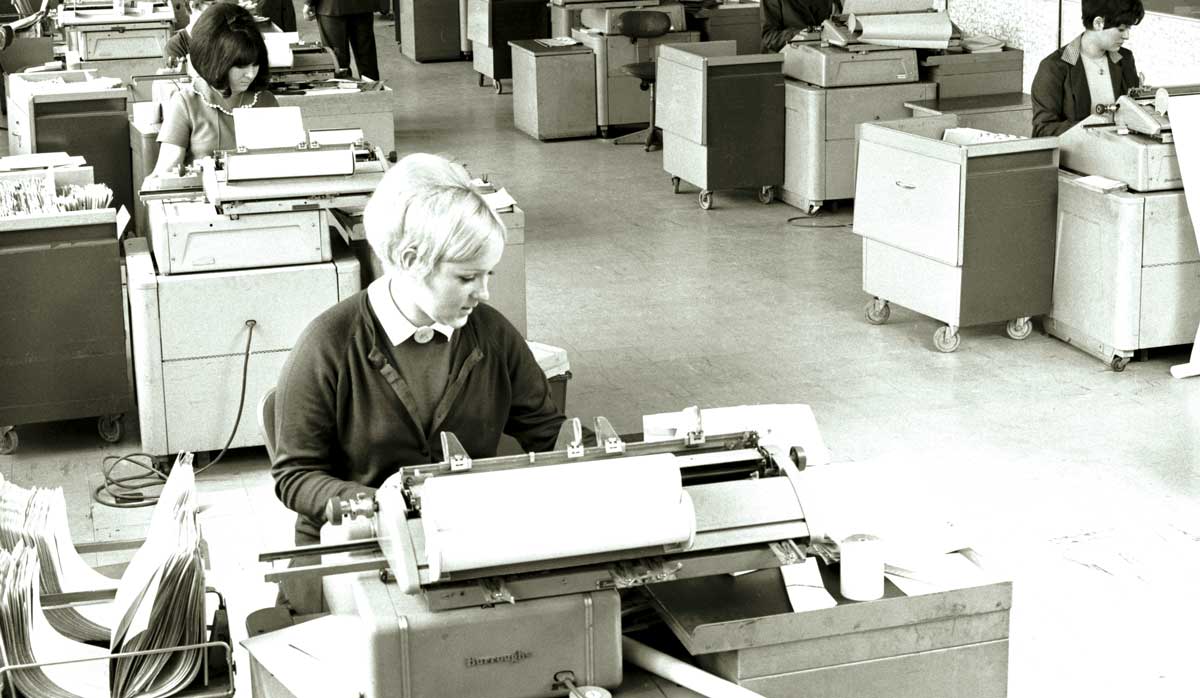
[949,0,1200,92]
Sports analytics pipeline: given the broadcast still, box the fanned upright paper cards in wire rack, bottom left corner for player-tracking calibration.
[0,456,205,698]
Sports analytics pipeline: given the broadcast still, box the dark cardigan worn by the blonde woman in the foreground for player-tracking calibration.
[271,291,564,543]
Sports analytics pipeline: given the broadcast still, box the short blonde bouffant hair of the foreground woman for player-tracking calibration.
[362,152,506,277]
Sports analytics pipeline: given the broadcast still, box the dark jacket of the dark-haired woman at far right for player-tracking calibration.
[1030,37,1140,137]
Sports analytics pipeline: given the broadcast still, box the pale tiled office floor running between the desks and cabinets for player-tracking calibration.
[0,10,1200,698]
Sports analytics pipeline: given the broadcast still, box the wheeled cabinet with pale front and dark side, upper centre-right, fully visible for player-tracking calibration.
[655,41,784,210]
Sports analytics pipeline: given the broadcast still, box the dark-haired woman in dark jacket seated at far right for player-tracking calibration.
[1030,0,1146,137]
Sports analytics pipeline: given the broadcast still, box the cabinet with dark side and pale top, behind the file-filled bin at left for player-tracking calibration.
[8,71,133,225]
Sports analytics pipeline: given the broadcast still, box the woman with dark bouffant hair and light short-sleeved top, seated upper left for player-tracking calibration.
[154,2,280,175]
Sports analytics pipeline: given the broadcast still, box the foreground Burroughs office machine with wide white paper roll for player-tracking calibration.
[260,410,816,698]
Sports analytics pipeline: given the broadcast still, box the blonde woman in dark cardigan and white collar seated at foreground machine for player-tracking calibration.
[271,155,564,613]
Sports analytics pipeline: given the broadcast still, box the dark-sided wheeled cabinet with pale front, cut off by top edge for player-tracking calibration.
[467,0,550,94]
